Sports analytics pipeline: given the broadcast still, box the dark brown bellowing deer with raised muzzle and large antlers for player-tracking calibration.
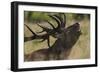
[24,13,82,61]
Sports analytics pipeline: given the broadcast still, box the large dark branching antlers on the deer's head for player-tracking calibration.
[24,13,66,47]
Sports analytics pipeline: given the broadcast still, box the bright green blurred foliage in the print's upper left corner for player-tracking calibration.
[24,11,50,23]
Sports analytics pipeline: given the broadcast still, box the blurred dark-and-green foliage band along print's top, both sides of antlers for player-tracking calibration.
[24,11,90,23]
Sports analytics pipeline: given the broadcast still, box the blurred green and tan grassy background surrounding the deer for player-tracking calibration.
[24,11,90,59]
